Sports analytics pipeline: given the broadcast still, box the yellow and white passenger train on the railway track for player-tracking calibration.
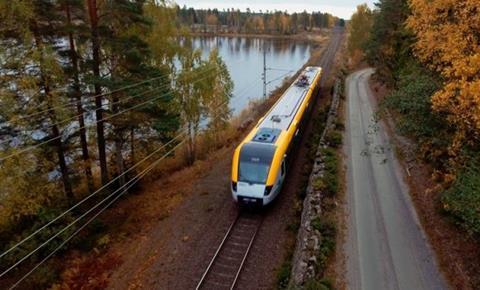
[231,67,322,206]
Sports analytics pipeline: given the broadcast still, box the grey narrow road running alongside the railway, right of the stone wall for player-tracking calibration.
[344,69,448,290]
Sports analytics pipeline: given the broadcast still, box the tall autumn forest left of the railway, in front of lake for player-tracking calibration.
[0,0,233,286]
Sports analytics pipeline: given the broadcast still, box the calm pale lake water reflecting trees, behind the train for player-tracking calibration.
[193,37,311,114]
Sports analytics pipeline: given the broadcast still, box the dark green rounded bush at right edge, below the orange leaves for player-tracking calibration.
[442,161,480,235]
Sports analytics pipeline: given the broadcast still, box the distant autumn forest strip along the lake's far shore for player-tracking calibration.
[175,6,345,35]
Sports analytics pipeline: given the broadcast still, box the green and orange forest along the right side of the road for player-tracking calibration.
[349,0,480,237]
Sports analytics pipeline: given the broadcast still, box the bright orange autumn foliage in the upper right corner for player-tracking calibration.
[407,0,480,148]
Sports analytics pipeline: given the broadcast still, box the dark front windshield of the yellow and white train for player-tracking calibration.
[238,143,276,184]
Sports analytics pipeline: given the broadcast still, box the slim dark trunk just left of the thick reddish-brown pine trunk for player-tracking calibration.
[65,3,95,192]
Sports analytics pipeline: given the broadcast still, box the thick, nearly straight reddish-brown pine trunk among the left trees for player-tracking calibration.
[87,0,108,184]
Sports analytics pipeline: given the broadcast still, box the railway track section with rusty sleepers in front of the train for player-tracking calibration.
[195,212,263,290]
